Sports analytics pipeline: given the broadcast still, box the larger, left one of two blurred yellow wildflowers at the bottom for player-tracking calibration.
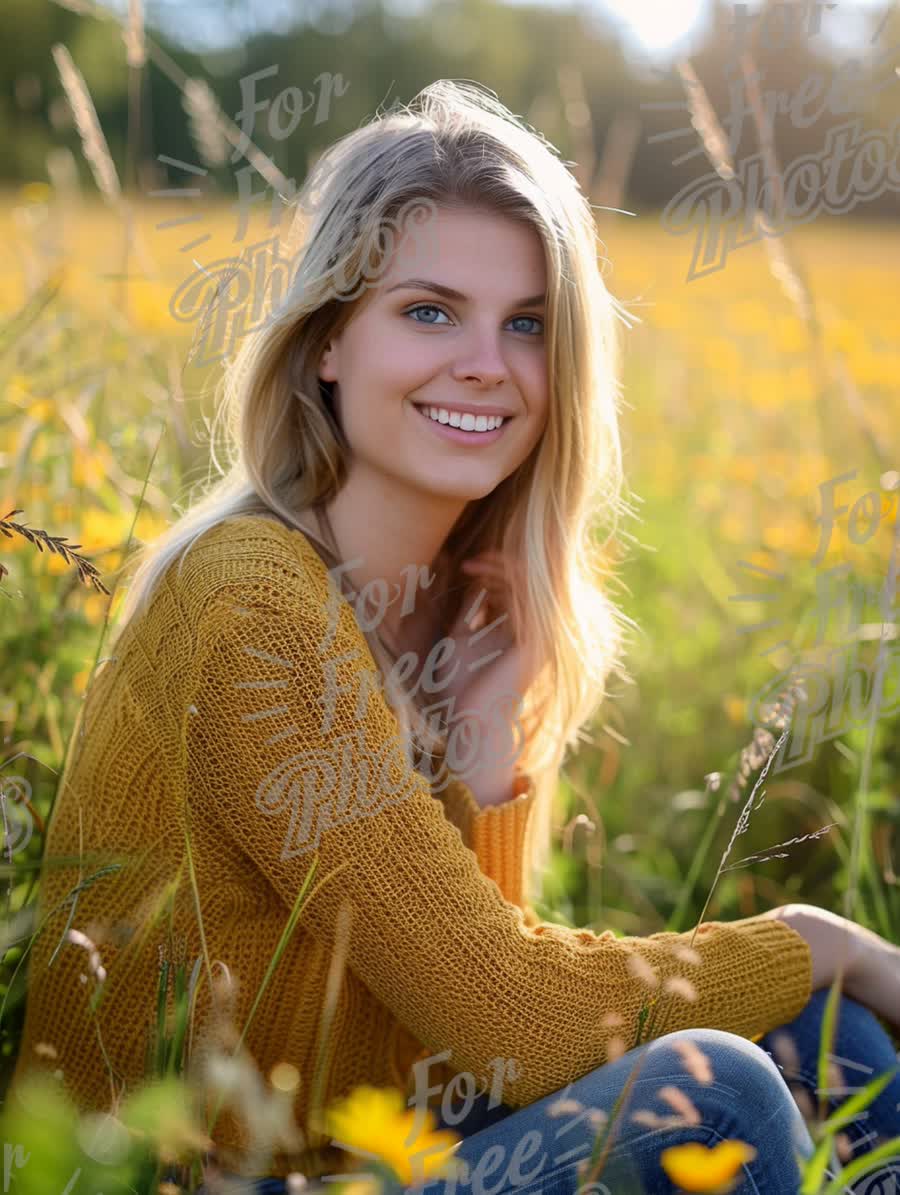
[325,1084,461,1187]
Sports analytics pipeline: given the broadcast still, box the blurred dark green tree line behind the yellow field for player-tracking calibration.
[0,0,900,216]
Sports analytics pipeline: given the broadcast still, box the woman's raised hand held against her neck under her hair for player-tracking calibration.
[441,551,535,804]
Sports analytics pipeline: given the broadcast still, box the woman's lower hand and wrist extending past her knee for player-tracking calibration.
[763,905,900,1030]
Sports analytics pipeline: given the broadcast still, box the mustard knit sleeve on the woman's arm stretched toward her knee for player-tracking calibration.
[185,560,812,1107]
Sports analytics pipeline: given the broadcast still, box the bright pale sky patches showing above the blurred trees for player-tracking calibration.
[106,0,884,65]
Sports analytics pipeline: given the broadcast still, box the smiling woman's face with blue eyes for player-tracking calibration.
[319,208,547,502]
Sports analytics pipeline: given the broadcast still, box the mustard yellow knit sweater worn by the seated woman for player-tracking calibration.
[13,515,812,1177]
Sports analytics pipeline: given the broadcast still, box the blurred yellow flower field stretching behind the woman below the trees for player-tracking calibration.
[0,182,900,932]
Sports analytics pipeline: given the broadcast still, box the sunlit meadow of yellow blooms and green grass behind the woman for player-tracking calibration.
[0,183,900,1191]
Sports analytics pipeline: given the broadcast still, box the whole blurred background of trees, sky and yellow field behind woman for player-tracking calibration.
[0,0,900,1099]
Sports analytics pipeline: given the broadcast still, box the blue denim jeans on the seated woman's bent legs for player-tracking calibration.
[404,988,900,1195]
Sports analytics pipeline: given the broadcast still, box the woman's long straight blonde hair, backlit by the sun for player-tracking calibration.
[114,80,635,897]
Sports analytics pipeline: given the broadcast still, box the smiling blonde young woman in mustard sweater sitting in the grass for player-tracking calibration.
[17,81,900,1195]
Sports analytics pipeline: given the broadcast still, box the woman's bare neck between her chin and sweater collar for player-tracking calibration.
[326,466,467,649]
